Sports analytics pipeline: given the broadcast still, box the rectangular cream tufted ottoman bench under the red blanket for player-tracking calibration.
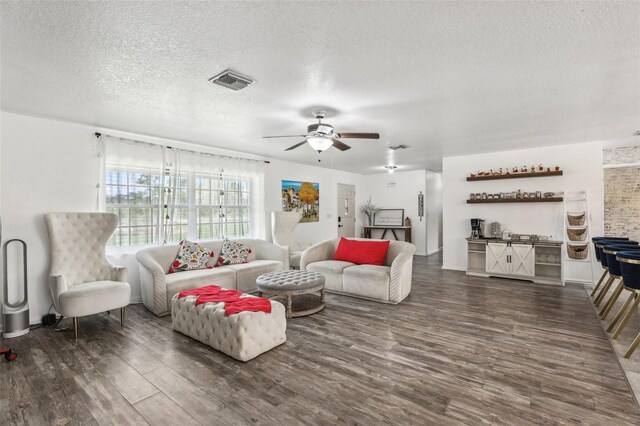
[171,294,287,361]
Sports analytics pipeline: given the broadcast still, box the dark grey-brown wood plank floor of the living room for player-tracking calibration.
[0,256,640,425]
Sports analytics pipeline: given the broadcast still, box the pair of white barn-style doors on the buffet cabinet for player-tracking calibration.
[486,243,536,277]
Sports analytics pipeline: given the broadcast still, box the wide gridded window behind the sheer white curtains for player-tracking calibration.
[105,166,252,246]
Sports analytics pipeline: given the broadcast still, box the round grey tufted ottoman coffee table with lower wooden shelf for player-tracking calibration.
[256,270,324,318]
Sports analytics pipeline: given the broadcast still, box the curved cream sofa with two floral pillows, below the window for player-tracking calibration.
[136,239,289,316]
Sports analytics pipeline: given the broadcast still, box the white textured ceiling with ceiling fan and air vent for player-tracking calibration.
[0,1,640,173]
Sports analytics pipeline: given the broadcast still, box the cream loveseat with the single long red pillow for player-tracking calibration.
[300,238,416,304]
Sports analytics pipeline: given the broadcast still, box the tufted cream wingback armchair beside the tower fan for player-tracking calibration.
[44,213,131,339]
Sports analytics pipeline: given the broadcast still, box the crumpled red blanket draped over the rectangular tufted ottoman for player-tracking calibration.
[178,285,271,316]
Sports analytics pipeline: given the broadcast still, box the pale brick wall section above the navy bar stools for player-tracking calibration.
[604,166,640,241]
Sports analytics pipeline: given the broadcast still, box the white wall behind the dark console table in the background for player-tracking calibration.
[356,170,427,256]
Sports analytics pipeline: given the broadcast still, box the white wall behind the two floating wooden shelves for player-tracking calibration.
[442,142,603,281]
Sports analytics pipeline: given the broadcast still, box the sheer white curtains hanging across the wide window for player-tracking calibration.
[96,135,265,246]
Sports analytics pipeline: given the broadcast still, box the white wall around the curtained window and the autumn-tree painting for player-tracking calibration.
[0,112,362,323]
